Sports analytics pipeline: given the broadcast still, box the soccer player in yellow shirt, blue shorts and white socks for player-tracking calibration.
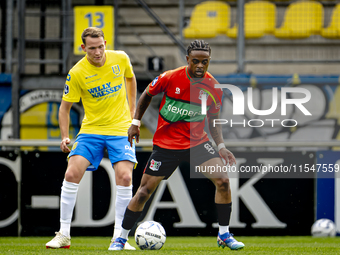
[46,27,137,249]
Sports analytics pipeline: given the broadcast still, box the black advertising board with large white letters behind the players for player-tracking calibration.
[0,151,315,236]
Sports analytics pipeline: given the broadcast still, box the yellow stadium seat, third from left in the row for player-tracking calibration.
[275,1,323,39]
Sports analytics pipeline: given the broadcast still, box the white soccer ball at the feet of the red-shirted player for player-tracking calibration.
[135,221,166,250]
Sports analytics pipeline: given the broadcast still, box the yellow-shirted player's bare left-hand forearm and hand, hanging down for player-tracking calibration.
[59,100,73,153]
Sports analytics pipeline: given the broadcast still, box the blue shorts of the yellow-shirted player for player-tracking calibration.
[68,134,137,171]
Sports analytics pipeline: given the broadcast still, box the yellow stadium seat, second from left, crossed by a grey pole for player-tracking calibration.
[227,1,276,39]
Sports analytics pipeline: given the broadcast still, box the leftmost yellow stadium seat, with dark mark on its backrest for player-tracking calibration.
[183,1,230,38]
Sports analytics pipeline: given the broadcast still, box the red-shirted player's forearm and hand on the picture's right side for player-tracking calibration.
[208,112,236,166]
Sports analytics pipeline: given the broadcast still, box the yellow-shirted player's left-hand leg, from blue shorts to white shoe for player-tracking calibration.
[46,134,103,249]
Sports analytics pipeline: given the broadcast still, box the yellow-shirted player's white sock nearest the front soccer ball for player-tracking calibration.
[113,185,132,239]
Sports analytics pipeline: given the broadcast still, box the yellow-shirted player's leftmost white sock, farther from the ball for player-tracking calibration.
[60,180,79,236]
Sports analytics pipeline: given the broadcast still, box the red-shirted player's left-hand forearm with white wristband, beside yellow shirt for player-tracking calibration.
[128,90,152,146]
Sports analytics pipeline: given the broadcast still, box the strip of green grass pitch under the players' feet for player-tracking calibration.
[0,236,340,255]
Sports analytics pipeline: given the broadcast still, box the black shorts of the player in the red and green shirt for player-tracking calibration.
[144,142,220,179]
